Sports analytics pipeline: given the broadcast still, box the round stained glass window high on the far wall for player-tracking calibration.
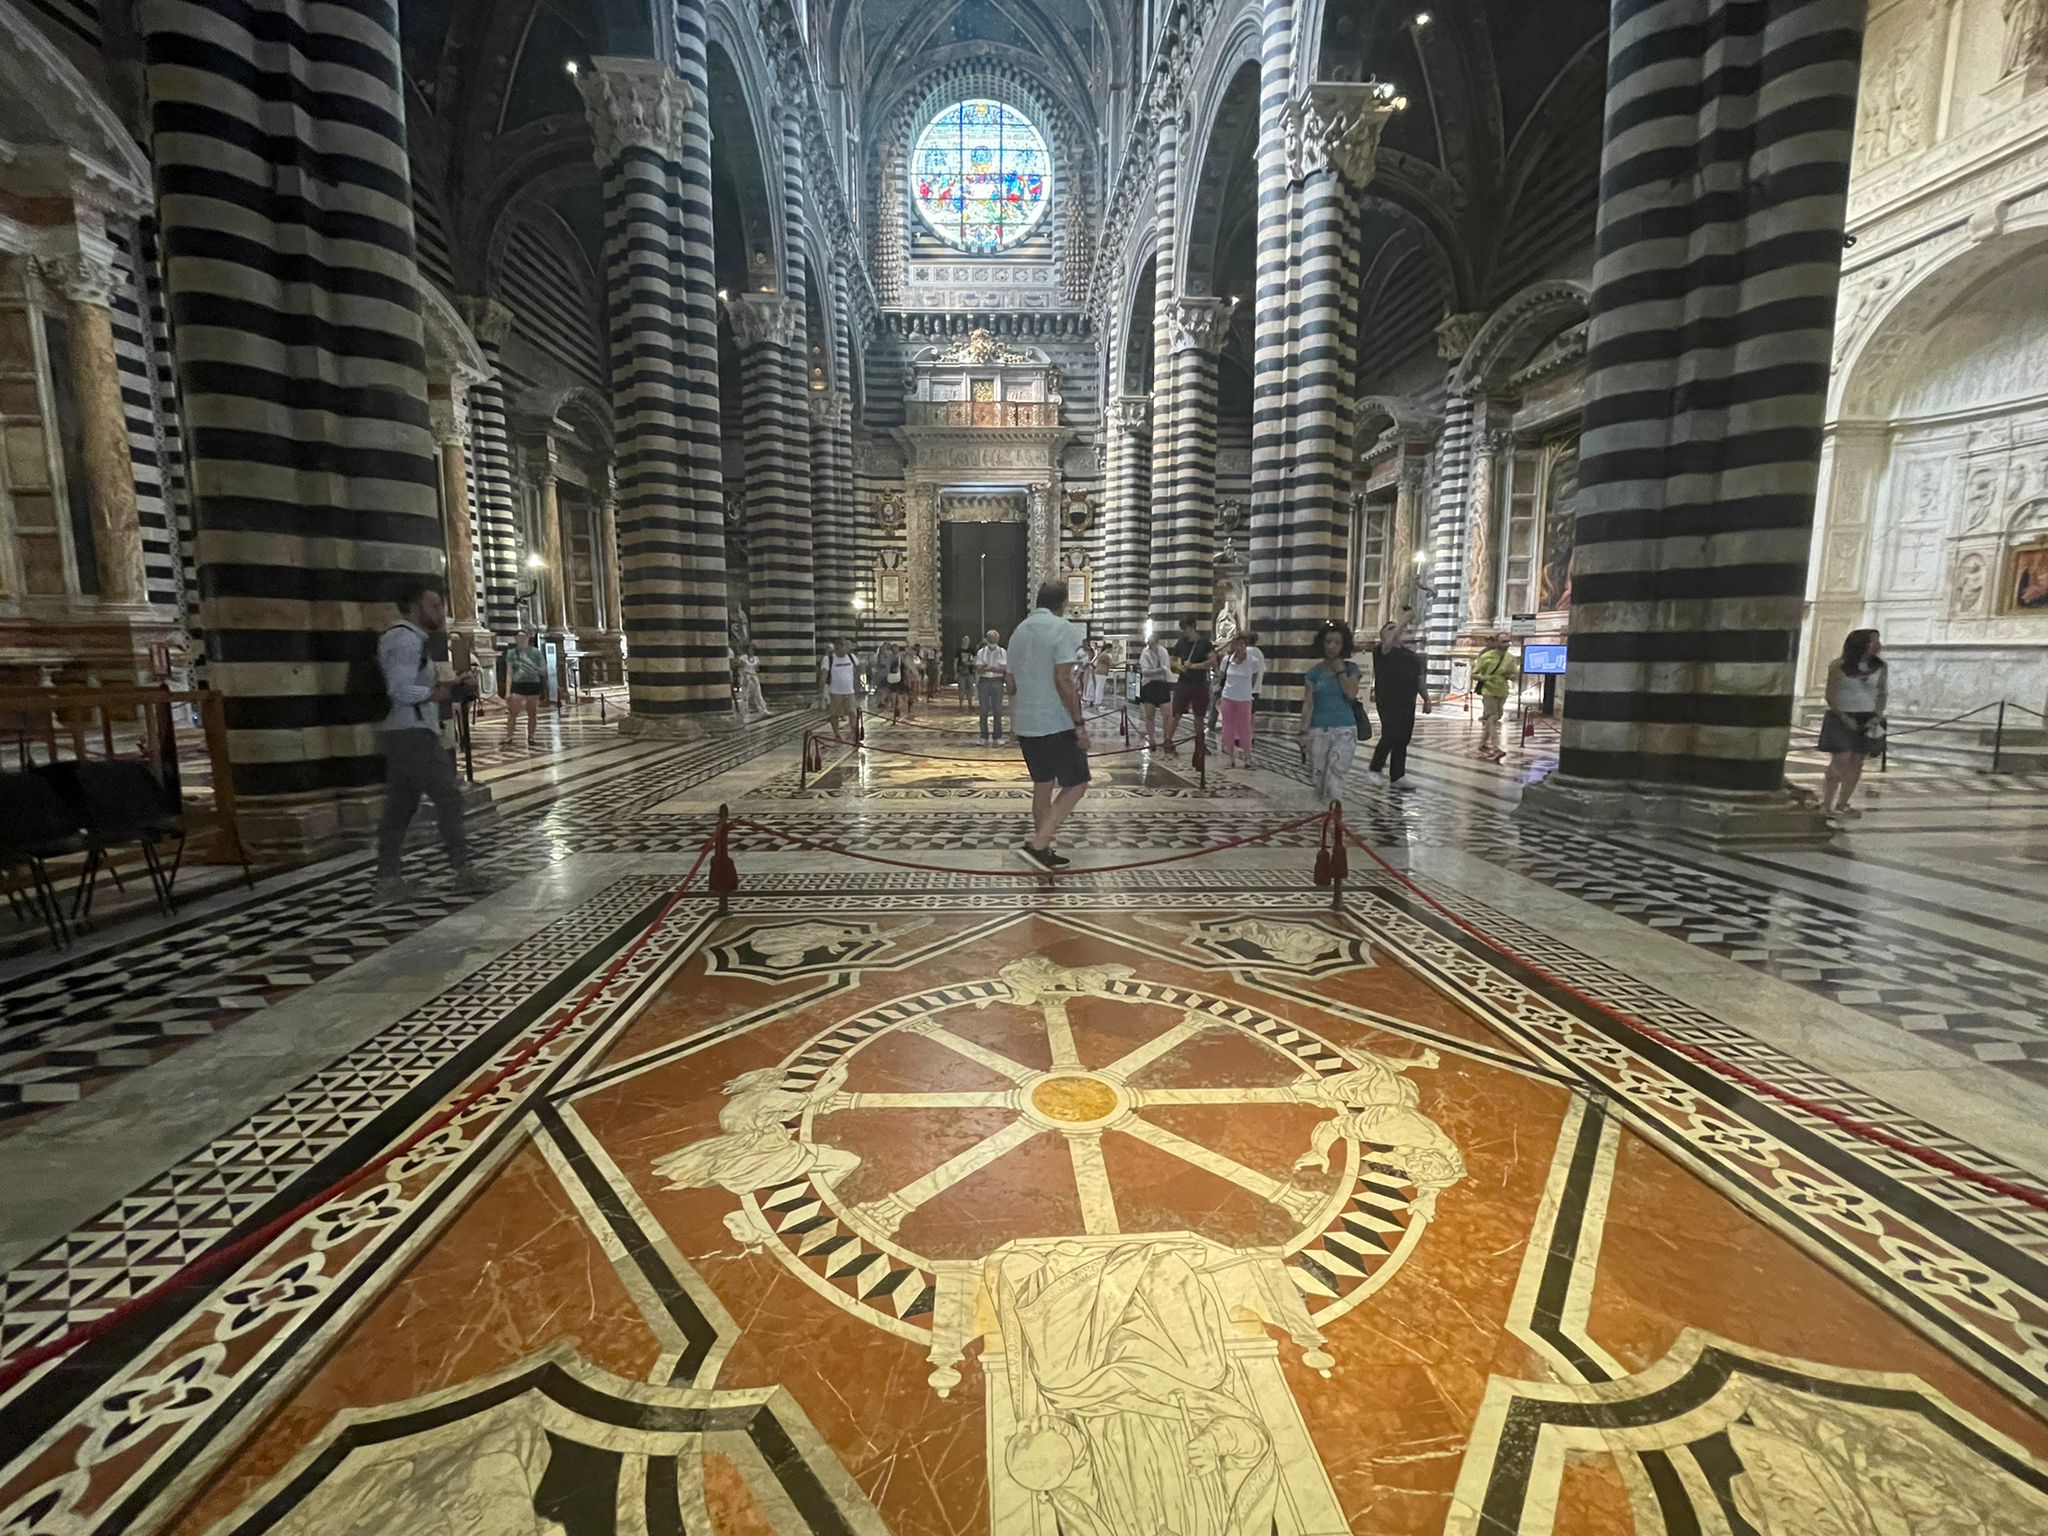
[909,100,1053,252]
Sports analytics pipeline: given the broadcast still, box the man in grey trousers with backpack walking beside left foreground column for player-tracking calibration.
[377,582,492,901]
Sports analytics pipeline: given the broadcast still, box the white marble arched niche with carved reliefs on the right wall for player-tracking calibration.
[1800,225,2048,719]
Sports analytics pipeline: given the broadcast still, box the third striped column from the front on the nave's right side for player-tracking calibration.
[1149,297,1235,633]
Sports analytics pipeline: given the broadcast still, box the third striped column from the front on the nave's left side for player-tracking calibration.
[725,293,817,692]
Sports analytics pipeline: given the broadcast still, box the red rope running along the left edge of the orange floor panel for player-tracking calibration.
[0,838,711,1397]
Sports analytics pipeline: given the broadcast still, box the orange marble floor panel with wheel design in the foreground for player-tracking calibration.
[167,897,2048,1536]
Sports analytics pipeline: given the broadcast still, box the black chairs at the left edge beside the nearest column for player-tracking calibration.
[0,758,184,948]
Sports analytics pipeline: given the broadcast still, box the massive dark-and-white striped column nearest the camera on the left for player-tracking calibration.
[137,0,440,854]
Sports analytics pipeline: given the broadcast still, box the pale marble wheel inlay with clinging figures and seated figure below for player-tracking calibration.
[638,958,1464,1532]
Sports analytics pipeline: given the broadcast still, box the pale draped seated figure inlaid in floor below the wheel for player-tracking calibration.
[985,1241,1278,1536]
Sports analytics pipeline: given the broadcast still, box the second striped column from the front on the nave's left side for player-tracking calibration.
[578,54,731,735]
